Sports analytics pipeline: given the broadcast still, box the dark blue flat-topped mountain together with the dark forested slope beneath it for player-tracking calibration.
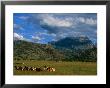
[49,37,97,61]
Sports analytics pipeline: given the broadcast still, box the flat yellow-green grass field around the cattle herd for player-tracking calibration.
[14,60,97,75]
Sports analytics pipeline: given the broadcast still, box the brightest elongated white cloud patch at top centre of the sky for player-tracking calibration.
[40,14,73,27]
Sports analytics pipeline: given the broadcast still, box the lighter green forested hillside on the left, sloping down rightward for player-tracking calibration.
[14,40,64,60]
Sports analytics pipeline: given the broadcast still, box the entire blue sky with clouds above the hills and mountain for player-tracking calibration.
[13,13,97,44]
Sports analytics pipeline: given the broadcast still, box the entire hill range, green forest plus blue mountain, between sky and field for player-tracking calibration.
[14,37,97,61]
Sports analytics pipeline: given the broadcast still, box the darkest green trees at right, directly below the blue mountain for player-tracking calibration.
[60,47,97,62]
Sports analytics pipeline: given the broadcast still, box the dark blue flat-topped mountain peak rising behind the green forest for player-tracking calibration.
[49,37,94,49]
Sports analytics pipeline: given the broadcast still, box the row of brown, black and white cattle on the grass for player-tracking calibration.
[14,66,55,72]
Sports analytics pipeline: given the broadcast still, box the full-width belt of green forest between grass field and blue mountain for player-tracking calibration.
[14,40,97,61]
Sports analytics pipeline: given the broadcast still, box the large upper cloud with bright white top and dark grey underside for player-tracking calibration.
[34,14,97,34]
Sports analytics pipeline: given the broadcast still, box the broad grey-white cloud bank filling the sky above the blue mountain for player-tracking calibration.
[30,13,97,40]
